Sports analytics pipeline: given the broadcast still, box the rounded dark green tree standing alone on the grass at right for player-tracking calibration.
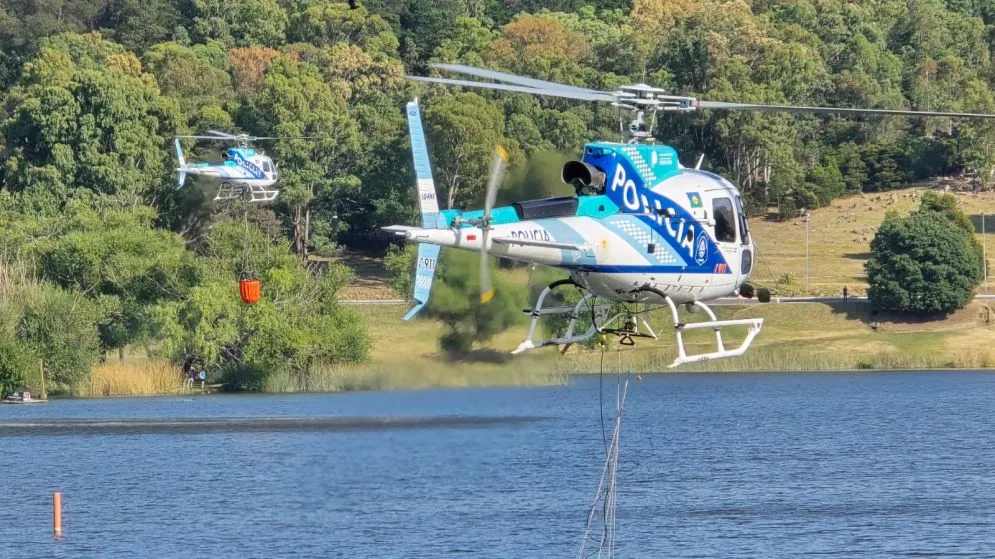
[865,196,984,314]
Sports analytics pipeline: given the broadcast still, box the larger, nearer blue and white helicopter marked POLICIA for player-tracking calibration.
[384,64,995,367]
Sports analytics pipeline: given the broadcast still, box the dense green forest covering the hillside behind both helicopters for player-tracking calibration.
[0,0,995,390]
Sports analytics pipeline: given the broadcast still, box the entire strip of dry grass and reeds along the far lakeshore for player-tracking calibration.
[17,302,995,398]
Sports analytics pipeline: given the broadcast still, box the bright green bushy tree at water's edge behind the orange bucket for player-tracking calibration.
[153,221,370,389]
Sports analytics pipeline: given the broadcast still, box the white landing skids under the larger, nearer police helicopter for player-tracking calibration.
[512,280,764,368]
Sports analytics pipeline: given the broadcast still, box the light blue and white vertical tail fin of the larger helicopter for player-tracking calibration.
[404,100,439,320]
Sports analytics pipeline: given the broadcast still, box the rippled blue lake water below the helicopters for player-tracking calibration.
[0,372,995,558]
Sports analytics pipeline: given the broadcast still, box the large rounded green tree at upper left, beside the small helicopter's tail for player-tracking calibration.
[2,35,179,203]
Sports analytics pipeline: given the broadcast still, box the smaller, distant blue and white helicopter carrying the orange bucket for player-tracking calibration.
[174,130,280,202]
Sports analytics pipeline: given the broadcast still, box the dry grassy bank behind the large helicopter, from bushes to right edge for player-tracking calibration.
[356,303,995,378]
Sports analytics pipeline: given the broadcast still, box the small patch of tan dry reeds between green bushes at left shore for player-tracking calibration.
[76,360,186,397]
